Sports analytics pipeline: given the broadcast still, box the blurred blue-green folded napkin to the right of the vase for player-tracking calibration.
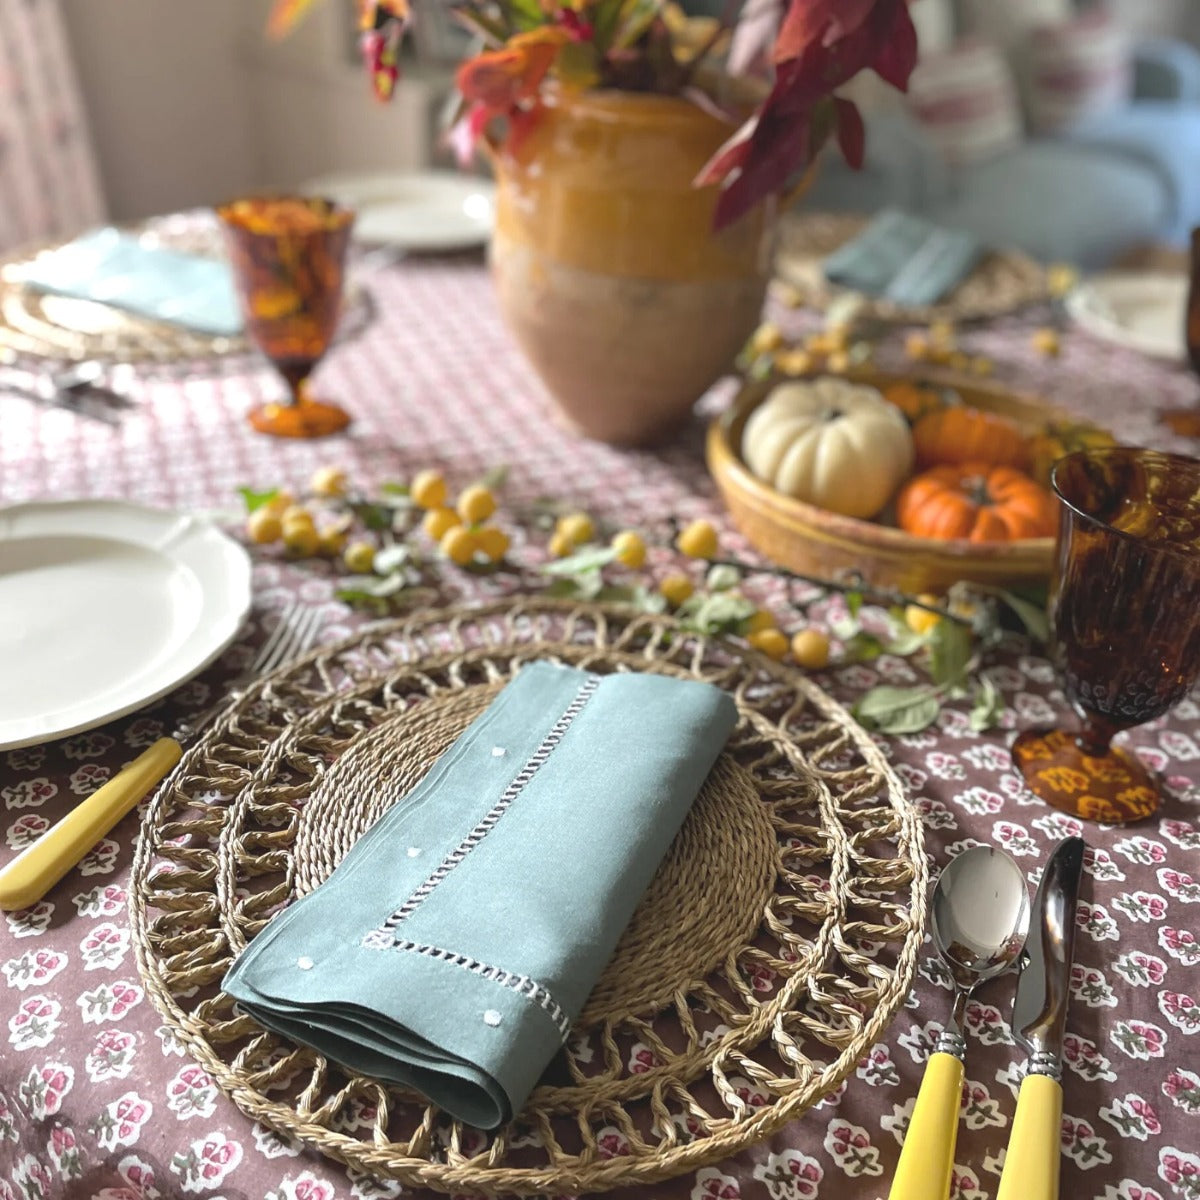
[824,209,983,308]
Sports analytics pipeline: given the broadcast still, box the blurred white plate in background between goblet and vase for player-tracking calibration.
[302,170,496,251]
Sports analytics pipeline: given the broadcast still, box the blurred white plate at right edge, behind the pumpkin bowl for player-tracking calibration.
[1067,271,1188,362]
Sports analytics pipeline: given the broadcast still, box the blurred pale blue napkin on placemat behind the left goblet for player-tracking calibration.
[16,227,242,337]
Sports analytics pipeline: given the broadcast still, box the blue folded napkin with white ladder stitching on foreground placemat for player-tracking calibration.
[223,662,737,1129]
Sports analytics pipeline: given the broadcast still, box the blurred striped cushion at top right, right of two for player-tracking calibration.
[1028,8,1133,133]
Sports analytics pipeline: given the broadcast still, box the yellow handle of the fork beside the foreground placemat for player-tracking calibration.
[0,738,184,911]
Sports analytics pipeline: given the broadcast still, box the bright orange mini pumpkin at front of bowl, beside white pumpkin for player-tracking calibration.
[896,462,1058,541]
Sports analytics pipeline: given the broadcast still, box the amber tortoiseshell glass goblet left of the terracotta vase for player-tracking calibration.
[217,196,354,438]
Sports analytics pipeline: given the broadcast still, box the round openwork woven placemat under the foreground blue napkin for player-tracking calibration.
[130,600,928,1195]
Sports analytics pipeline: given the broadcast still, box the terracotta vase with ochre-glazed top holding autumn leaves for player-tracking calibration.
[491,91,773,445]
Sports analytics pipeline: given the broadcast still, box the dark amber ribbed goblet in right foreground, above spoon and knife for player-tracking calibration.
[1013,446,1200,824]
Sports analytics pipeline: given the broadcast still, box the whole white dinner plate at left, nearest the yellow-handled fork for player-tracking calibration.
[0,500,251,750]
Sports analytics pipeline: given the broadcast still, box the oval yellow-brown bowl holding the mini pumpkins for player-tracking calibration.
[707,370,1099,594]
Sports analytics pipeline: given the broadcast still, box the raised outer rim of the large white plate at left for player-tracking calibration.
[0,499,252,751]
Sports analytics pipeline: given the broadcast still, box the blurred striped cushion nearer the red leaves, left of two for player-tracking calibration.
[908,41,1021,163]
